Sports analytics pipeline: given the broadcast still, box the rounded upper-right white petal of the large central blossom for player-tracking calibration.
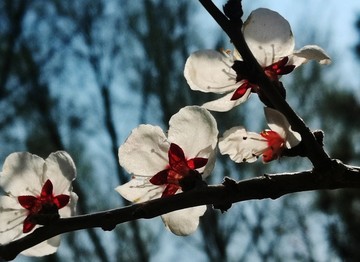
[168,106,218,163]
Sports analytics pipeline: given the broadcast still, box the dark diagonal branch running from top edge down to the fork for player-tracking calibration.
[199,0,331,170]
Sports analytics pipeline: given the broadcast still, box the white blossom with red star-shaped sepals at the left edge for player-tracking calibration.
[0,151,77,256]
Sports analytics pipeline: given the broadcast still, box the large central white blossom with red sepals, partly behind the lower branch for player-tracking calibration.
[116,106,218,235]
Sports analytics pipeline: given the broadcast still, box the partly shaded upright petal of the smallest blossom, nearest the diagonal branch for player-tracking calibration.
[264,107,301,148]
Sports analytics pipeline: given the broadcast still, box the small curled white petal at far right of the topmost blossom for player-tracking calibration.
[289,45,331,67]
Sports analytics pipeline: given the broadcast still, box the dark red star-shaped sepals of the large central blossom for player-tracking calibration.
[150,143,208,197]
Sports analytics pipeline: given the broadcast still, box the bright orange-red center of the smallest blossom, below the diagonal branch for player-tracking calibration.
[260,130,285,163]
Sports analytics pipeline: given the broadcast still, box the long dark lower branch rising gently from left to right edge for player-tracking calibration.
[0,160,360,260]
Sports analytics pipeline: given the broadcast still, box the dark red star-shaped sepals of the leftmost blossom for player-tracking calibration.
[18,179,70,233]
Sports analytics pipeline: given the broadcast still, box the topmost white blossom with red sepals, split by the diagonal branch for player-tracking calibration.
[184,8,331,112]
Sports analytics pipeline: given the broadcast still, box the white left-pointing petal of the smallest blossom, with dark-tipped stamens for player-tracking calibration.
[219,126,268,163]
